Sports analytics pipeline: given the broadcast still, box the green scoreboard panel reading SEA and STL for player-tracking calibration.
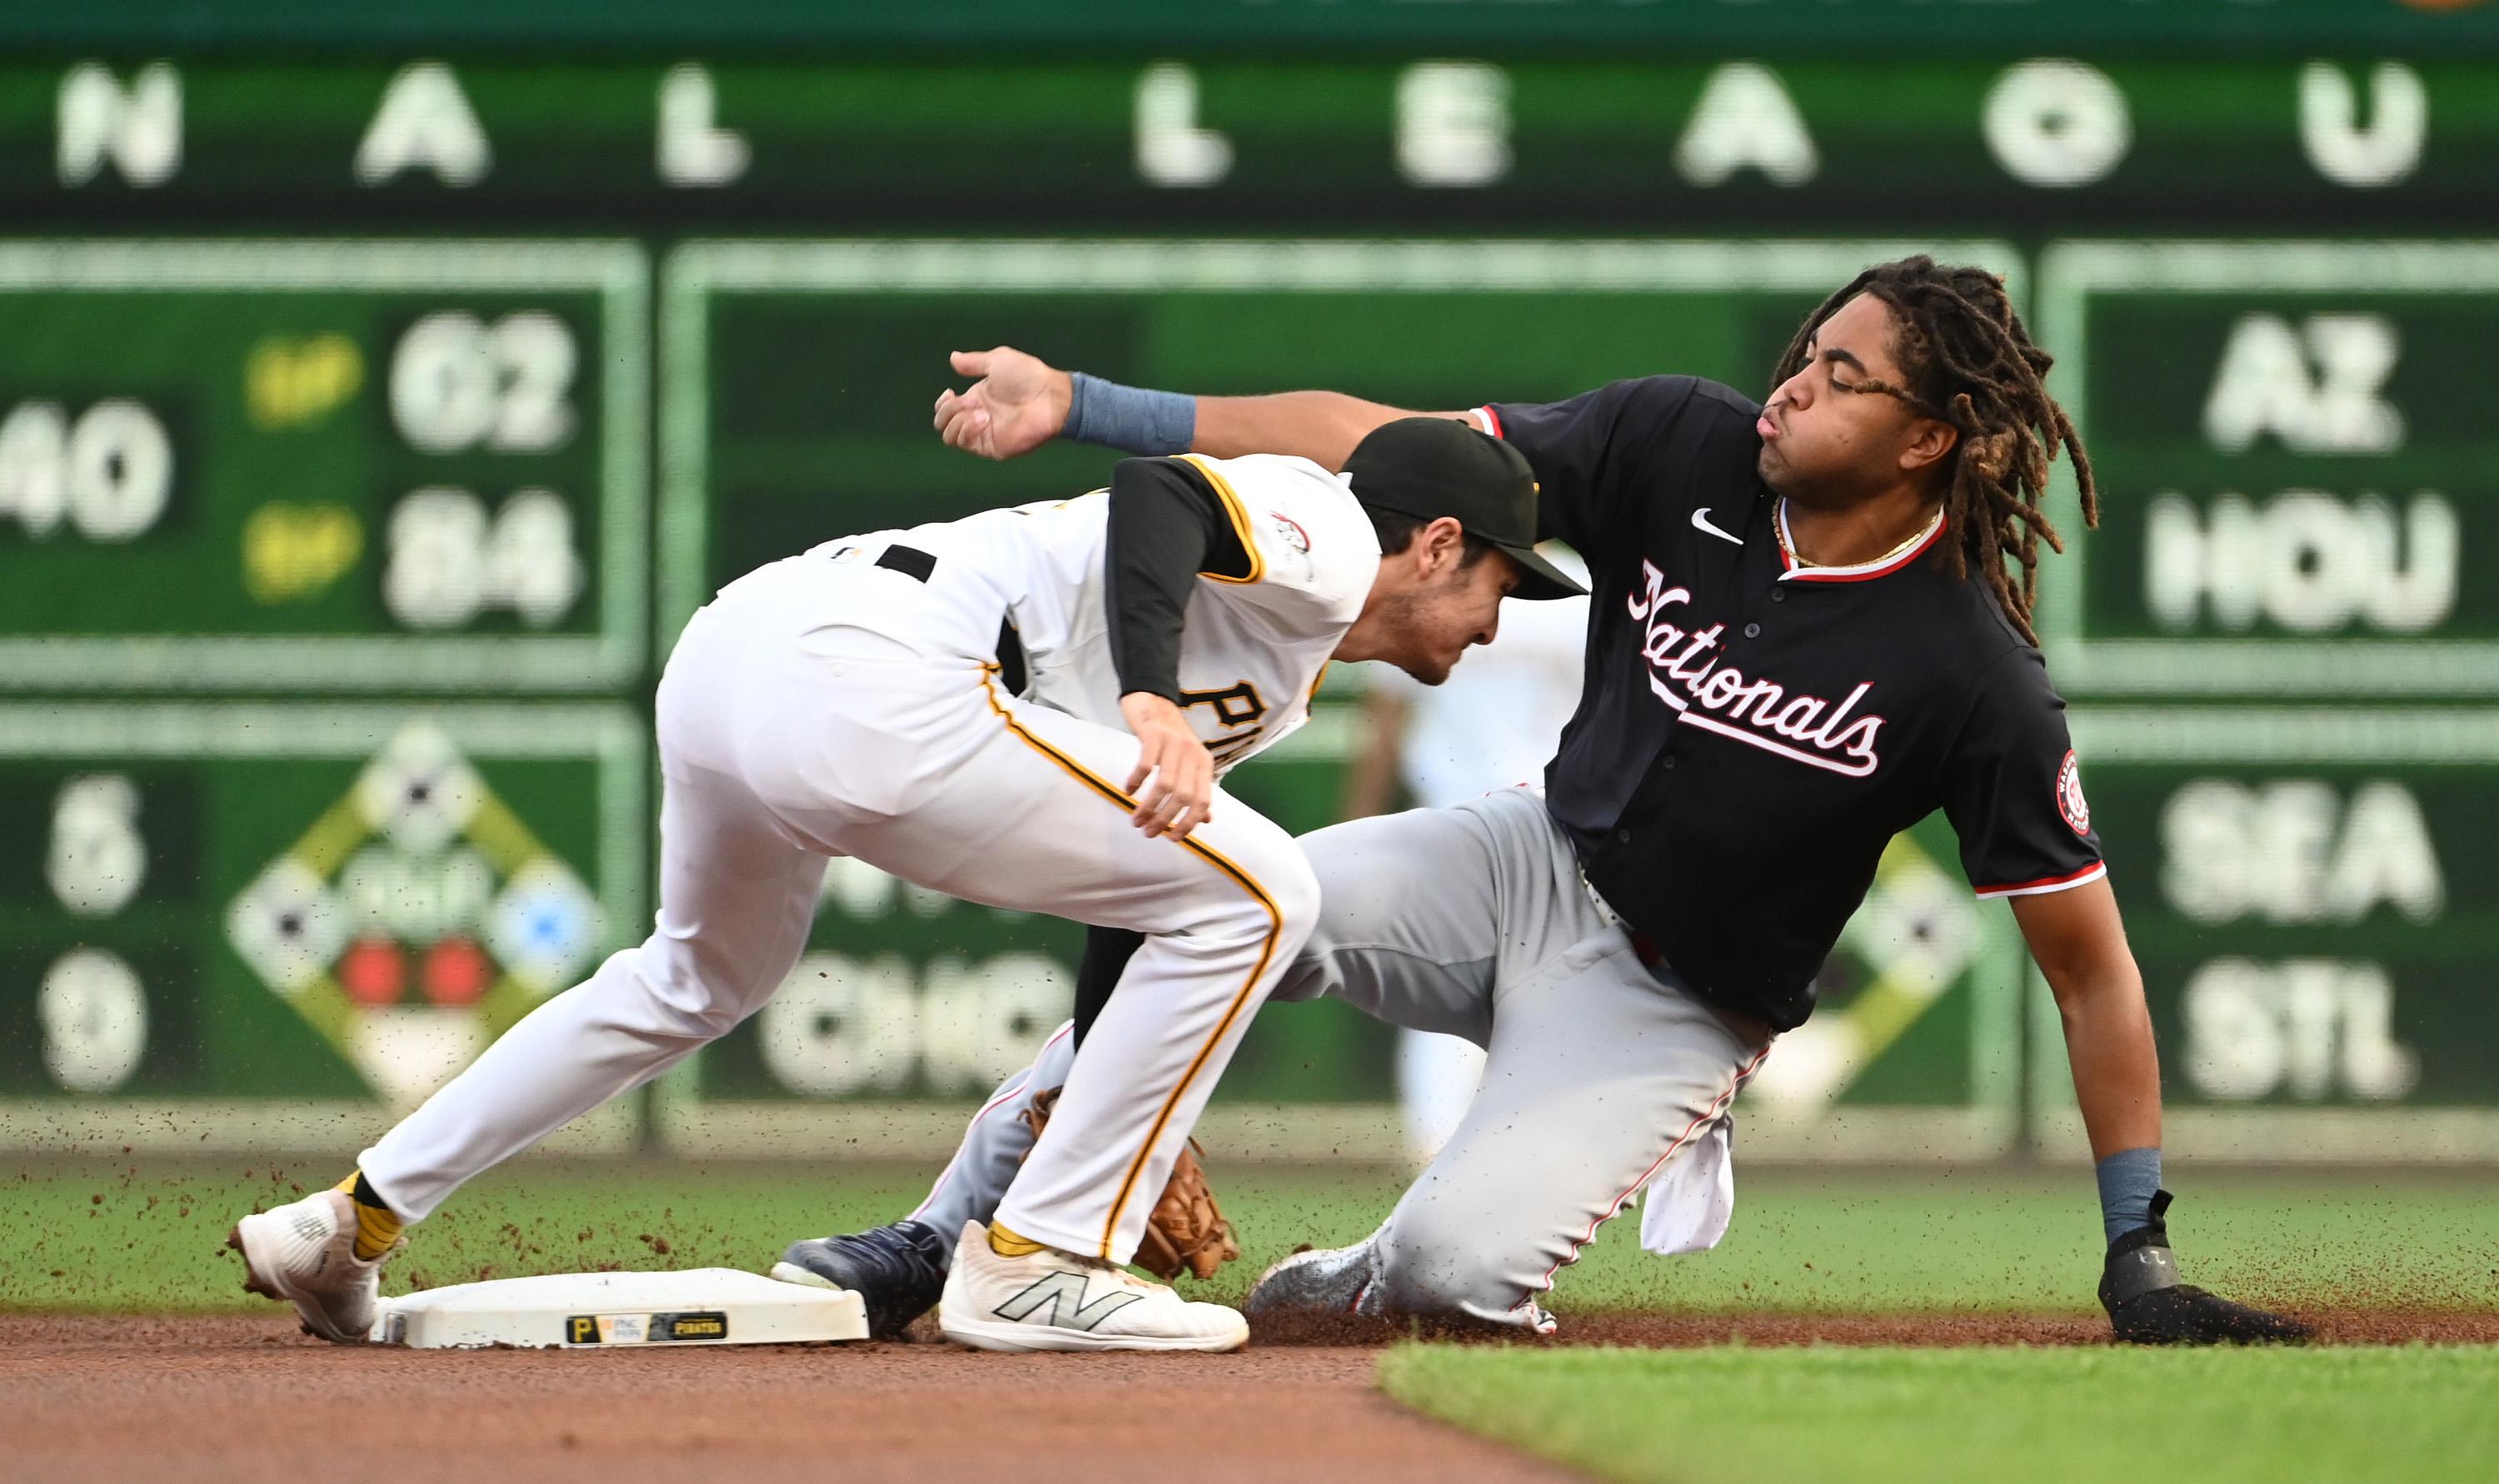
[2032,705,2499,1162]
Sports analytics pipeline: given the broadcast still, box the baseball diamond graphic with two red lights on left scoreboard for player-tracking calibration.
[225,722,605,1107]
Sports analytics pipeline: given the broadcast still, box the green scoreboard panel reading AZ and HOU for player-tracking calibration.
[2039,242,2499,697]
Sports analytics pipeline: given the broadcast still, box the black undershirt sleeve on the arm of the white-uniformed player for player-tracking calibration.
[1102,460,1250,705]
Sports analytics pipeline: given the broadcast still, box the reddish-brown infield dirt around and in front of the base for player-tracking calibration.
[0,1309,2499,1484]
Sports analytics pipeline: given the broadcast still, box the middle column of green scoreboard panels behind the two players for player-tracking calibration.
[660,240,2019,1157]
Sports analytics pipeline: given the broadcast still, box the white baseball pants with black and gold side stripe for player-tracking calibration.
[360,555,1319,1262]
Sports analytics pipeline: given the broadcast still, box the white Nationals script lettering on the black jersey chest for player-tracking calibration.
[1627,562,1882,777]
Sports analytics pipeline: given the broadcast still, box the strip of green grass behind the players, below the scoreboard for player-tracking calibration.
[0,1157,2499,1319]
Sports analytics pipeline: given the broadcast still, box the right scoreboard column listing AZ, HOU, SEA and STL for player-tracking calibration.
[2032,242,2499,1159]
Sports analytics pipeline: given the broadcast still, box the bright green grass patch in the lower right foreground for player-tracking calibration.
[1379,1344,2499,1484]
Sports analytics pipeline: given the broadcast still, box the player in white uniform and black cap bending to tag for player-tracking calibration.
[230,410,1577,1349]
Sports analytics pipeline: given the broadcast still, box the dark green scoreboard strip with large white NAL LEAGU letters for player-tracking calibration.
[0,55,2499,237]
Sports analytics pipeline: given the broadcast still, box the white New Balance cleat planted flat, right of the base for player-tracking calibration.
[937,1222,1250,1352]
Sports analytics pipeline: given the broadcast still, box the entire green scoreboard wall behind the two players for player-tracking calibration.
[0,0,2499,1159]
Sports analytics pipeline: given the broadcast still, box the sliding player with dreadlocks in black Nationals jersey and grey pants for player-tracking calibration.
[792,257,2304,1342]
